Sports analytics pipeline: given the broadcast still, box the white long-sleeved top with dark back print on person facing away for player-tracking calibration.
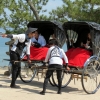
[45,46,68,65]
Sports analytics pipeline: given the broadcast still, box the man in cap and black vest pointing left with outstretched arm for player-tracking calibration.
[2,28,37,88]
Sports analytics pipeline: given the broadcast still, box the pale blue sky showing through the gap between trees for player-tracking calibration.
[0,0,63,33]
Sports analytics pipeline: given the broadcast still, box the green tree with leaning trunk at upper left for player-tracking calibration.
[0,0,48,34]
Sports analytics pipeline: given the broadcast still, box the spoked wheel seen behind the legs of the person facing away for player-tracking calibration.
[52,71,72,88]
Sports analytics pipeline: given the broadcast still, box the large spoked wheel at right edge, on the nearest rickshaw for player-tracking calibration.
[81,57,100,94]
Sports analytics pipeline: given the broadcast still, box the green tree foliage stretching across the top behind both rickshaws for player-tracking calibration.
[0,0,100,34]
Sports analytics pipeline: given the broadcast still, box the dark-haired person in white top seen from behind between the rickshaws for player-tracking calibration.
[40,39,70,95]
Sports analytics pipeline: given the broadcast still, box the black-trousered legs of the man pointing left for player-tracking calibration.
[10,52,19,88]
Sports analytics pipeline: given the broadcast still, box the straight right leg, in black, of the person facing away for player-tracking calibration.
[56,65,62,94]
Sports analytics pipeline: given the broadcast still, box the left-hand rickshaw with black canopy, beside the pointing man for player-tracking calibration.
[20,21,66,86]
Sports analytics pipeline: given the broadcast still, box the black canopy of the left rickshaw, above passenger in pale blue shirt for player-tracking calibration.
[27,21,66,46]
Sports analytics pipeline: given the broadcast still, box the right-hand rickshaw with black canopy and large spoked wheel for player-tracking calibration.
[52,22,100,94]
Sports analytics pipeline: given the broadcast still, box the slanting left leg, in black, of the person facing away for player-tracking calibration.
[40,67,54,95]
